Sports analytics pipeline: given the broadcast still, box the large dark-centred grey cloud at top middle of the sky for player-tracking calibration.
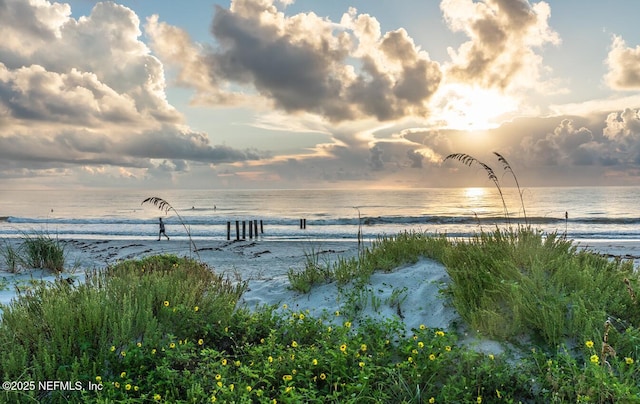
[147,0,442,122]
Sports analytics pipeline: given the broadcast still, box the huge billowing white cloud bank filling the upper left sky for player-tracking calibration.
[0,0,259,182]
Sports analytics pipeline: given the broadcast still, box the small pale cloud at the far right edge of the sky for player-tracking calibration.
[605,36,640,90]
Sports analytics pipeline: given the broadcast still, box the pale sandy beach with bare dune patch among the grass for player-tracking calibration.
[0,239,640,353]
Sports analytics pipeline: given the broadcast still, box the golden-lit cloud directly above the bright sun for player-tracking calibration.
[440,0,560,89]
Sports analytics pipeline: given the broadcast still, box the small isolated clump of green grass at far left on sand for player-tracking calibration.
[0,233,65,273]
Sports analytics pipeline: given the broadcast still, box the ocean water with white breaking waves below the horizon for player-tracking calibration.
[0,187,640,241]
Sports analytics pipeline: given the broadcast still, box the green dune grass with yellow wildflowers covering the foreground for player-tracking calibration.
[0,228,640,403]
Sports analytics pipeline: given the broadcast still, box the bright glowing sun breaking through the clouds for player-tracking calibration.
[436,84,518,130]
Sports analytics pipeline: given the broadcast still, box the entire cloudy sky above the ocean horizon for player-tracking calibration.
[0,0,640,189]
